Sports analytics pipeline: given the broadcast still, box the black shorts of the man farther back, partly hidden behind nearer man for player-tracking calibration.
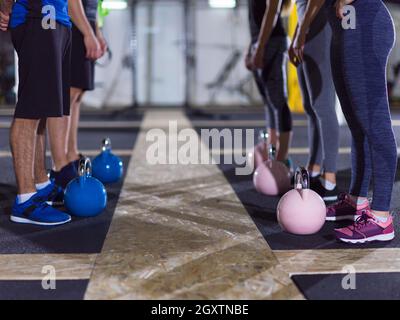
[71,21,96,91]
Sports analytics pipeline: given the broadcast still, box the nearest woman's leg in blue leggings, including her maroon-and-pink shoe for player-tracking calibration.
[332,0,397,243]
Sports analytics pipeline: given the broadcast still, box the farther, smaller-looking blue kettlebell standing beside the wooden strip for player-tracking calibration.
[92,138,124,183]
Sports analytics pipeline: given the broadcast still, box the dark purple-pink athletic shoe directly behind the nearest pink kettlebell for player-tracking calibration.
[326,193,369,221]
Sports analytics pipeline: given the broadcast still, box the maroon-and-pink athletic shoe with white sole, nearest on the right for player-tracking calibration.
[335,209,394,243]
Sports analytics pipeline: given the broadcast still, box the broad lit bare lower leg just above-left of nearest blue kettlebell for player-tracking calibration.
[47,116,69,171]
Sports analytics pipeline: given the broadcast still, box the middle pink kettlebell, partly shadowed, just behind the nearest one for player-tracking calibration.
[253,146,291,196]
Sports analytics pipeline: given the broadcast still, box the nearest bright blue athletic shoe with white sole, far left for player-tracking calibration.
[10,194,71,226]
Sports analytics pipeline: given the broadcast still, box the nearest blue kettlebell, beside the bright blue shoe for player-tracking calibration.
[64,158,107,217]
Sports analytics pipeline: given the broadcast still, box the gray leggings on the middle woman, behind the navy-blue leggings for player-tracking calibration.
[297,1,339,172]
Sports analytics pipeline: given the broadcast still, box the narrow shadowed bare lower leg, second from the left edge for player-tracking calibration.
[34,119,49,184]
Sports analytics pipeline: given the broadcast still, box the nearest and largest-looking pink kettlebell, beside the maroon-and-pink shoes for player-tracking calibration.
[277,168,326,235]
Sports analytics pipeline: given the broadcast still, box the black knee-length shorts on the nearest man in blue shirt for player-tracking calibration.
[11,18,71,119]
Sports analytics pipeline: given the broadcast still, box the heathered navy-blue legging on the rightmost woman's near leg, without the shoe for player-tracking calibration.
[343,0,397,215]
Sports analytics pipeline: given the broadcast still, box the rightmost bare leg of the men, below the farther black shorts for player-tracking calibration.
[67,88,83,162]
